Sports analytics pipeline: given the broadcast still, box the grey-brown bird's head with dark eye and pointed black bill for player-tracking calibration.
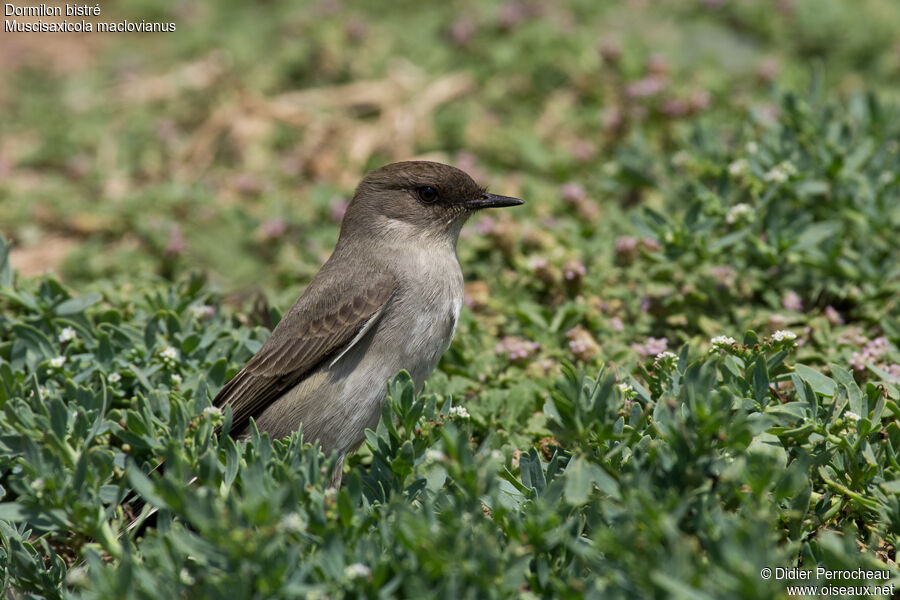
[341,161,523,245]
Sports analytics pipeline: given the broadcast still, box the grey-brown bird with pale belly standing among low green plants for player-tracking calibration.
[214,161,522,484]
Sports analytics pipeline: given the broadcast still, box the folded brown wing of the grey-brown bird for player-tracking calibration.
[213,272,396,431]
